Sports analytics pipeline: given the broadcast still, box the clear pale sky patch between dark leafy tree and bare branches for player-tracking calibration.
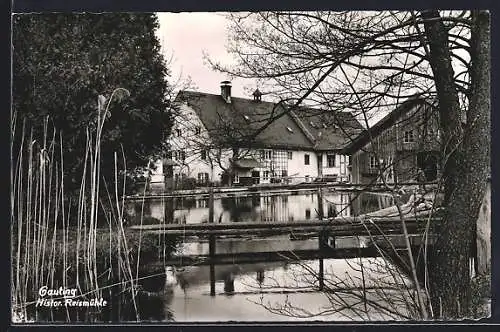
[156,12,256,98]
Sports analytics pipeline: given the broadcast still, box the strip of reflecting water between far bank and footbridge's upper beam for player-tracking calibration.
[127,191,393,224]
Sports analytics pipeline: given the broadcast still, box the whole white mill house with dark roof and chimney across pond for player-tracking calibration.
[152,81,363,186]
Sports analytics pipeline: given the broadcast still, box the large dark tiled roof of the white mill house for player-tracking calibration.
[176,91,363,150]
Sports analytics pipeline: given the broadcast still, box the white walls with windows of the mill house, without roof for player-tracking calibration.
[151,104,349,184]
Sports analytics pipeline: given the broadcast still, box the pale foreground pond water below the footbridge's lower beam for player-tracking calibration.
[115,254,409,322]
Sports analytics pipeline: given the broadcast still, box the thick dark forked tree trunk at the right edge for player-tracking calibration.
[422,11,490,318]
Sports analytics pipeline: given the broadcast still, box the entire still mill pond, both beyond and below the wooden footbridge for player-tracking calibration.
[21,191,411,322]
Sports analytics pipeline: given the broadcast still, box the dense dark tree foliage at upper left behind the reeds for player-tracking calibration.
[12,13,171,195]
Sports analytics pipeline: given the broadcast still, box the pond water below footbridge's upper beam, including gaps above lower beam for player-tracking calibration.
[22,236,411,322]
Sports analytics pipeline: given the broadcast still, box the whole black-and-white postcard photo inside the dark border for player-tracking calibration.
[10,10,491,324]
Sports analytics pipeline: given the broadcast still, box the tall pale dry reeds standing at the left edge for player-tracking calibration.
[11,89,158,321]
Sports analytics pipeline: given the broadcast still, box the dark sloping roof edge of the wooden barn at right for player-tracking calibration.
[341,98,432,154]
